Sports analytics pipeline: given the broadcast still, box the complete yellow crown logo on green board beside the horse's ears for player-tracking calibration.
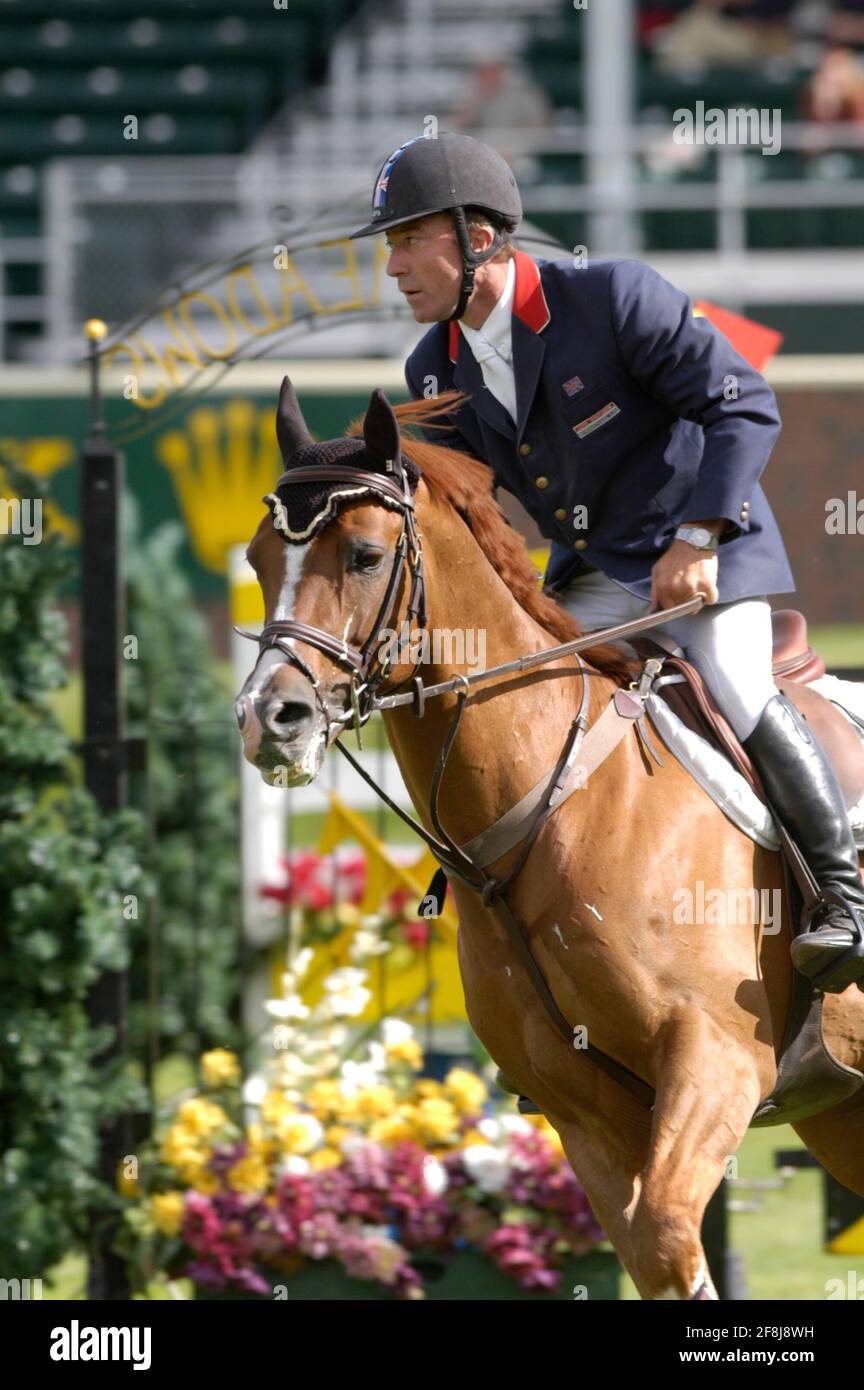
[156,399,282,574]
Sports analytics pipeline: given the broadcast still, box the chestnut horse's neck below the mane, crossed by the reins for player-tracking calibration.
[383,503,614,840]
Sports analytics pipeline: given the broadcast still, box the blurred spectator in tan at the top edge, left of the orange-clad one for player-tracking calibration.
[649,0,797,74]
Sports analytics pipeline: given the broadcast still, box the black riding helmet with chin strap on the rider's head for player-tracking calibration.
[350,131,522,318]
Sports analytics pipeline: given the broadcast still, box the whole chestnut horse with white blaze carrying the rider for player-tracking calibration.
[238,381,864,1298]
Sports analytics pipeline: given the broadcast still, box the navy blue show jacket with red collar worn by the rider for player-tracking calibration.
[406,252,795,603]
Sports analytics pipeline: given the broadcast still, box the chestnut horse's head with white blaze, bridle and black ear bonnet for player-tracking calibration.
[235,377,425,787]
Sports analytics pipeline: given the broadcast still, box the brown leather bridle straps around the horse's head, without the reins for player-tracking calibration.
[235,457,426,738]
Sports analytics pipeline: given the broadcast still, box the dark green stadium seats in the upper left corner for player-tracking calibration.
[0,0,360,353]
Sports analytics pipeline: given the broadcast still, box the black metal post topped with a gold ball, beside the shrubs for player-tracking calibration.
[81,325,132,1300]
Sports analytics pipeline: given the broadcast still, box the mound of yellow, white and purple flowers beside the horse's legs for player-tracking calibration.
[124,930,614,1298]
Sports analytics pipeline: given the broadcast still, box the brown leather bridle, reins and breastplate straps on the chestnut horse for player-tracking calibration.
[235,456,704,1108]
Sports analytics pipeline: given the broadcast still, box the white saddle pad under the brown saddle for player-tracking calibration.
[646,676,864,851]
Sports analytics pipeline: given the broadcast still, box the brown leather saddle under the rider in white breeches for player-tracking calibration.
[631,609,864,1129]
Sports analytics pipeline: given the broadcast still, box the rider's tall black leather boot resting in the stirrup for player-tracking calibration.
[743,694,864,994]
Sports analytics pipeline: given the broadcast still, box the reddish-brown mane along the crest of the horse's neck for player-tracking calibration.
[347,391,633,681]
